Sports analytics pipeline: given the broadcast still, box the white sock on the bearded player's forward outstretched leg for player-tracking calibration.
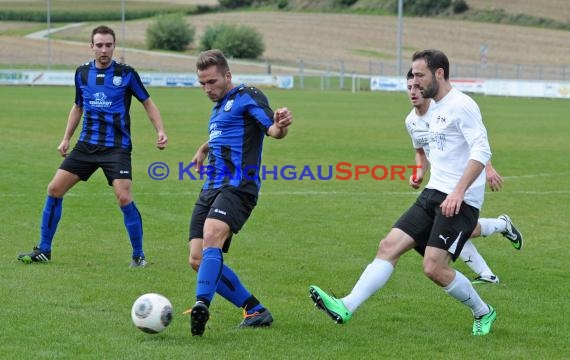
[341,259,394,312]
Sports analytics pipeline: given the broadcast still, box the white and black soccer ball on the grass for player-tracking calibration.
[131,293,172,334]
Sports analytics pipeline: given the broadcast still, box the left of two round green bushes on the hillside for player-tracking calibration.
[146,14,195,51]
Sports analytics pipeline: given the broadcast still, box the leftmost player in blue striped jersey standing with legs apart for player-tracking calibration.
[18,26,168,267]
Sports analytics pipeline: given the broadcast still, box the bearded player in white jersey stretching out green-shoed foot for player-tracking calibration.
[309,50,497,335]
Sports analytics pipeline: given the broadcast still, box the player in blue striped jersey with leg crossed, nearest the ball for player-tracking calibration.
[188,50,293,336]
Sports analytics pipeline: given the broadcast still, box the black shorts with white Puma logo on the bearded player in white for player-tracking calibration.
[394,189,479,261]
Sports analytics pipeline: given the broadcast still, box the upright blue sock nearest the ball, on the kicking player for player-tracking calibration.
[196,248,224,306]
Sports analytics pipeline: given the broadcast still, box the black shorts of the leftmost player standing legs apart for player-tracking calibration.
[59,141,132,186]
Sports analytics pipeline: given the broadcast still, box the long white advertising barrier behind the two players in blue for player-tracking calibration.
[0,70,294,89]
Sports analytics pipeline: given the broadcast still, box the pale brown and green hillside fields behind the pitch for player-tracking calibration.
[0,0,570,78]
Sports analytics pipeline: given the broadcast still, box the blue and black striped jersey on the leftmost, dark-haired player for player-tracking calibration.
[75,60,150,150]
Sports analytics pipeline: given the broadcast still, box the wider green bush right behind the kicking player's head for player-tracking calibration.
[200,24,265,59]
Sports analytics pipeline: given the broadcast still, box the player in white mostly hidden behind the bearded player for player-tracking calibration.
[405,69,523,284]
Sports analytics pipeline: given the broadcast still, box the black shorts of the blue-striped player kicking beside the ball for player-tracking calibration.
[189,187,257,252]
